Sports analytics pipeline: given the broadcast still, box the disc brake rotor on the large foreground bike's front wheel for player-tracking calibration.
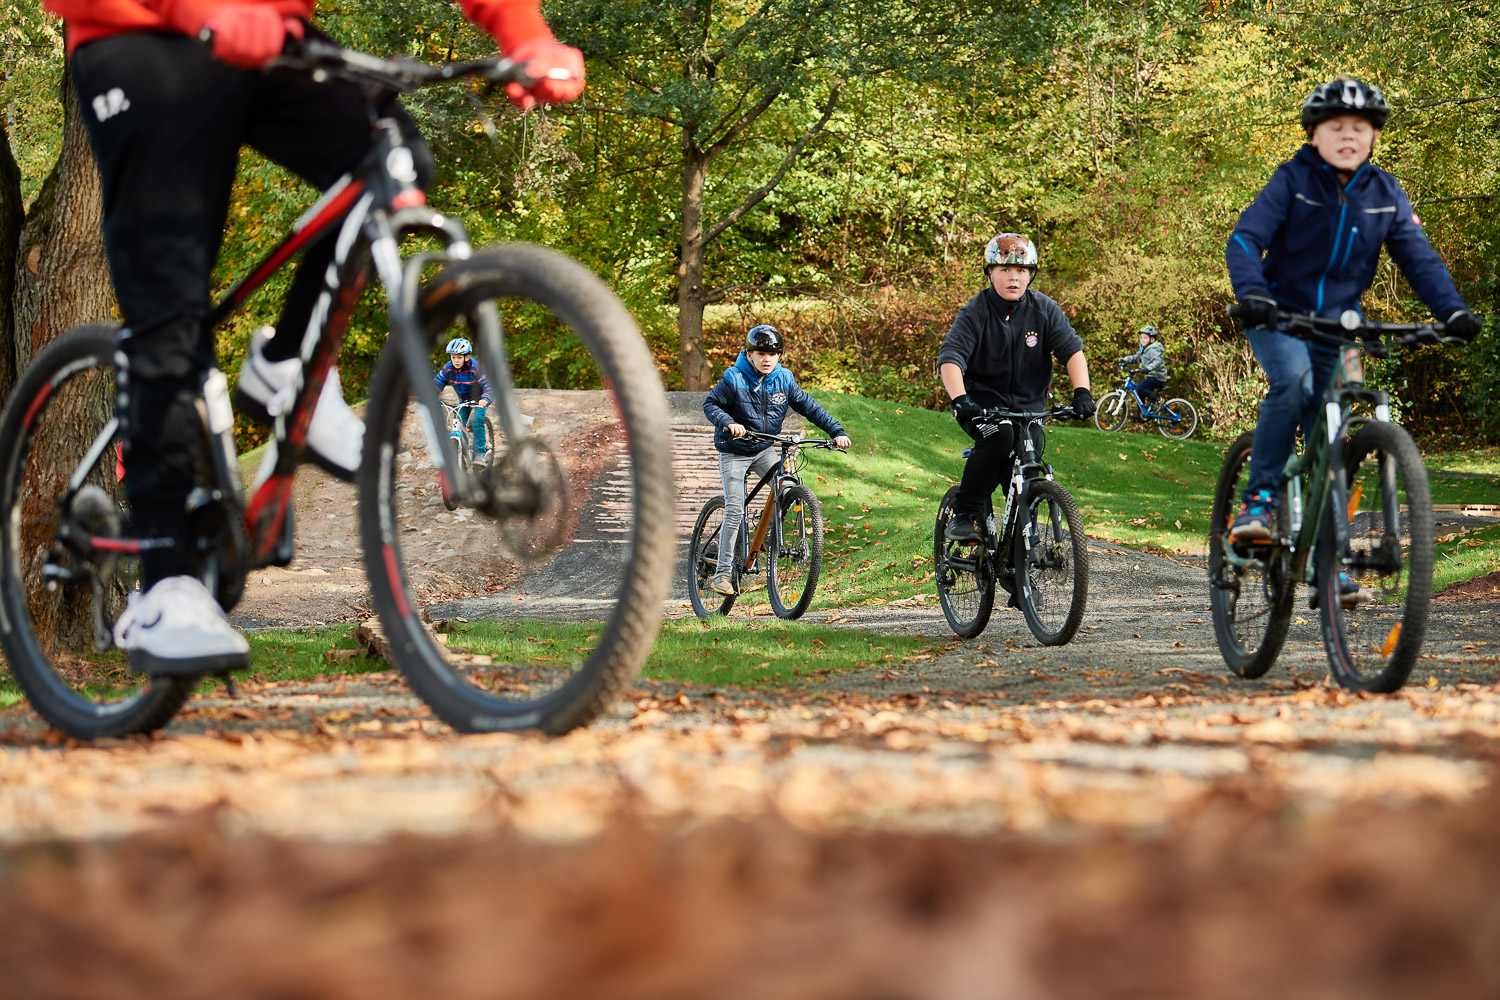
[491,438,570,562]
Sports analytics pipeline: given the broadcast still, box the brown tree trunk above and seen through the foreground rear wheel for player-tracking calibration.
[5,69,123,651]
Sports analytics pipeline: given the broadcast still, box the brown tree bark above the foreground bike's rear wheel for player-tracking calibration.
[9,69,114,375]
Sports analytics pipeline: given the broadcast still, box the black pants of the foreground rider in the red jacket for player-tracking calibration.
[72,31,431,586]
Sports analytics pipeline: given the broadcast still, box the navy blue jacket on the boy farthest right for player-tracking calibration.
[1224,145,1464,319]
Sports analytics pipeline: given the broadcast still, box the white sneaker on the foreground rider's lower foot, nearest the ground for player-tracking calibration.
[114,576,251,675]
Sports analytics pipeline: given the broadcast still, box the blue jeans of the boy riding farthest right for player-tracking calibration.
[1241,330,1338,502]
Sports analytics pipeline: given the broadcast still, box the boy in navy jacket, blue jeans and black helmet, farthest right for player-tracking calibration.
[1226,76,1481,563]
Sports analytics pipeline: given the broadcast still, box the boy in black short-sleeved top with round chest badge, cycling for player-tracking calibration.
[938,232,1095,541]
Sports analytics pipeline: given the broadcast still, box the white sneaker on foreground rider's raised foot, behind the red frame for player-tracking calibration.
[234,327,365,481]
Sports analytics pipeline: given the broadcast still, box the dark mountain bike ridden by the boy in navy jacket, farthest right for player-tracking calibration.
[1209,306,1457,691]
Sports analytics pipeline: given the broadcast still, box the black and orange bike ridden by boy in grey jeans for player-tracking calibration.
[687,430,843,619]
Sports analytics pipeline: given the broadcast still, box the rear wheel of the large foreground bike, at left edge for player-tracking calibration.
[0,324,197,739]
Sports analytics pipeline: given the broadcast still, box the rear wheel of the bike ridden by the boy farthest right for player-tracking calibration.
[1209,430,1298,678]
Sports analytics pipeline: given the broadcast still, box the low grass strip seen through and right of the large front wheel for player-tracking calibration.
[450,618,932,688]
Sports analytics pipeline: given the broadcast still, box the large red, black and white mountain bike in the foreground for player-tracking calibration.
[0,42,675,739]
